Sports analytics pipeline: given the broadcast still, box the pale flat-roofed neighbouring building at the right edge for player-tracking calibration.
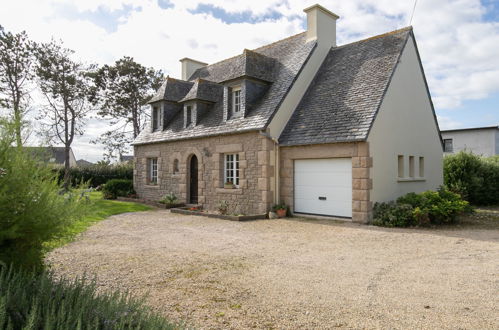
[440,125,499,157]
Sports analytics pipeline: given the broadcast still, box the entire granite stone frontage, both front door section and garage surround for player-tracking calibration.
[134,132,372,223]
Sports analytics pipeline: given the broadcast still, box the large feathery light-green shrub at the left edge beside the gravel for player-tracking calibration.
[0,122,86,268]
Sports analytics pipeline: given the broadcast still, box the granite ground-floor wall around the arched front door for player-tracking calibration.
[134,132,275,214]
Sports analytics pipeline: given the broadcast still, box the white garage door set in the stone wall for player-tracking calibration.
[294,158,352,217]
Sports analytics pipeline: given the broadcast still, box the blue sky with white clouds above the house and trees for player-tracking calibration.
[0,0,499,161]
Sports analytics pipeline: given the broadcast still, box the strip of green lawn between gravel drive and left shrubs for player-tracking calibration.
[44,192,152,251]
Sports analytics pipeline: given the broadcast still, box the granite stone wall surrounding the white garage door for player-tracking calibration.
[279,142,372,223]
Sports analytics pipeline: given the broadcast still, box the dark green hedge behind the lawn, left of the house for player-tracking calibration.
[55,163,133,188]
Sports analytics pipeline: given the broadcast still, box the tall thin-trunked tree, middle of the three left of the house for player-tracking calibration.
[36,40,92,189]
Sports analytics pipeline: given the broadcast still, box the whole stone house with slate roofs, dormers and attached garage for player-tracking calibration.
[133,5,442,223]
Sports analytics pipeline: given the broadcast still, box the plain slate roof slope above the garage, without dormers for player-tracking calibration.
[279,27,412,146]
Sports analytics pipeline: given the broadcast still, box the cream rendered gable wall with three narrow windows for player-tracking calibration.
[367,36,443,202]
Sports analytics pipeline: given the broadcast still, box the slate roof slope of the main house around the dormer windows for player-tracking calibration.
[133,32,316,145]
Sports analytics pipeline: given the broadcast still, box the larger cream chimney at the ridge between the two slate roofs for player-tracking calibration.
[303,4,340,47]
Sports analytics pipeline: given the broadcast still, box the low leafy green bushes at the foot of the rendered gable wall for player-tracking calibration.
[373,189,472,227]
